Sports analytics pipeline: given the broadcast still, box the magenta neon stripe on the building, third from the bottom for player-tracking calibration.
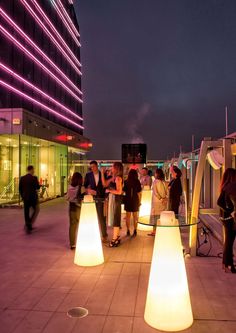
[0,25,83,103]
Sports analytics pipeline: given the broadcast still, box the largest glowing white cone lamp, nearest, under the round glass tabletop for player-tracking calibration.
[144,211,193,331]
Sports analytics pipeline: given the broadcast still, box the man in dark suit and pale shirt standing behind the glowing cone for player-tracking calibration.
[84,161,108,242]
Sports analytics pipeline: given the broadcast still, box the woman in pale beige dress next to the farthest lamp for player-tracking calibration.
[149,168,168,236]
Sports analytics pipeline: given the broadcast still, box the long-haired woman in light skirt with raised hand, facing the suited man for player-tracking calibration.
[102,162,123,247]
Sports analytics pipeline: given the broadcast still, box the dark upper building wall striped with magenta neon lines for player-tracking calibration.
[0,0,83,135]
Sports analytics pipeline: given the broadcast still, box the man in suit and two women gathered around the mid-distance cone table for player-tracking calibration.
[67,161,123,249]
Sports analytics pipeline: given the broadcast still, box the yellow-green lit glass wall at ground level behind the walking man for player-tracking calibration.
[0,135,87,207]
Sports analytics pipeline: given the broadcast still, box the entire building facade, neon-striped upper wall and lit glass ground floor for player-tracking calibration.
[0,0,91,204]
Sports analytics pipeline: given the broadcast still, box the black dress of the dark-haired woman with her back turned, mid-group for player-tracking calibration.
[124,179,142,212]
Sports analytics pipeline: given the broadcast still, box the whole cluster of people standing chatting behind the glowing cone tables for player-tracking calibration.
[67,161,182,249]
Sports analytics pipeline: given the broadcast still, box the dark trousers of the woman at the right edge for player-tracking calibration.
[223,218,236,266]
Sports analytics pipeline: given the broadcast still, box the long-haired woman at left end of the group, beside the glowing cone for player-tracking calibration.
[66,172,83,250]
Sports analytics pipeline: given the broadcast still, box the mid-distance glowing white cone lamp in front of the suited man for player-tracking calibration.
[74,195,104,266]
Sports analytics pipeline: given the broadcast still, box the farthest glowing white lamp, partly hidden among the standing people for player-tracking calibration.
[138,186,153,231]
